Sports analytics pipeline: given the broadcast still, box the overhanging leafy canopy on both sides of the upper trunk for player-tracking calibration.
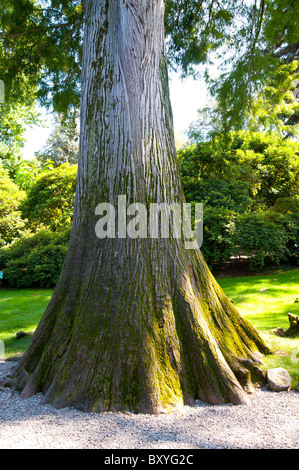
[0,0,299,130]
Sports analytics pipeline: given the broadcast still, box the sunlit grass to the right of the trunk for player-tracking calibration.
[217,269,299,386]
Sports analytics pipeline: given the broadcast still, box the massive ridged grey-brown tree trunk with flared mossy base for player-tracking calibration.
[5,0,268,413]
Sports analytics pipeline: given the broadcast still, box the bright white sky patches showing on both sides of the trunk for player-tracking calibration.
[22,73,207,159]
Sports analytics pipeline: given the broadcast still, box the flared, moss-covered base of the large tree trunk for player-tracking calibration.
[1,248,270,414]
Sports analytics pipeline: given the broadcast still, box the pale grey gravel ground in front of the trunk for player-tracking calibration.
[0,362,299,449]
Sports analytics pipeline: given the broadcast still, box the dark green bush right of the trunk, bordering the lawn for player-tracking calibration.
[201,206,298,269]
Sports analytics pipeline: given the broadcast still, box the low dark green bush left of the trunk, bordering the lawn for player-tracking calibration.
[0,228,70,288]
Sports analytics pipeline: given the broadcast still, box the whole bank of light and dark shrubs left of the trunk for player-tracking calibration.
[0,161,77,288]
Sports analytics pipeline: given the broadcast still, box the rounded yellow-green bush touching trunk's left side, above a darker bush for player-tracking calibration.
[21,163,77,230]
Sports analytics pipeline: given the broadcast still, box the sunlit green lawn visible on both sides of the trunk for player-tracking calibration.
[0,269,299,385]
